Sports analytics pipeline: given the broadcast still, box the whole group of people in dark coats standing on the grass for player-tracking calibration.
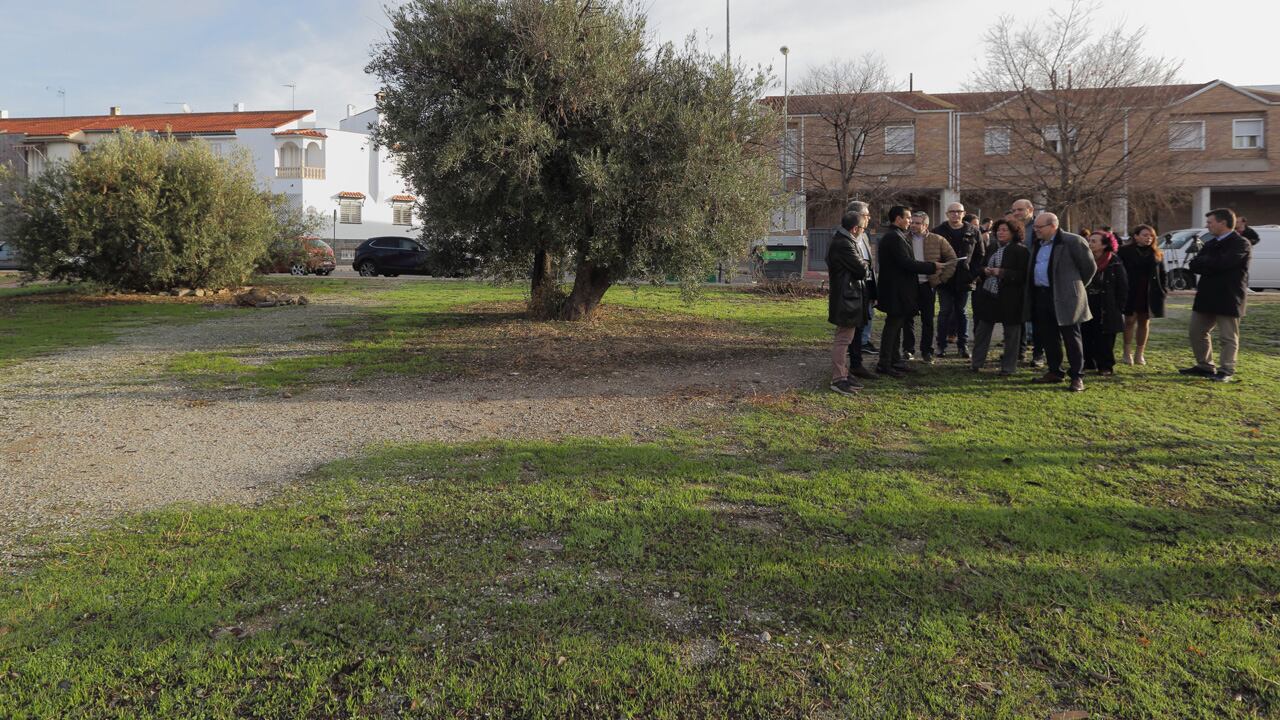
[827,200,1252,395]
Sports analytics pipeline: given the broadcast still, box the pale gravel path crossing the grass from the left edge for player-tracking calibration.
[0,301,822,571]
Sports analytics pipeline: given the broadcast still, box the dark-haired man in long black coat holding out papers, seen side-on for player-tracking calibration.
[876,205,942,378]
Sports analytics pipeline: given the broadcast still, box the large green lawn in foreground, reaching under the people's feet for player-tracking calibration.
[0,287,1280,719]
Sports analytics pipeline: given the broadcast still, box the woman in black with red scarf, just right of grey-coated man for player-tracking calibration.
[1080,231,1129,375]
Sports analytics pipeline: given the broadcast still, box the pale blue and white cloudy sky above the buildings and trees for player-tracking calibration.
[0,0,1280,126]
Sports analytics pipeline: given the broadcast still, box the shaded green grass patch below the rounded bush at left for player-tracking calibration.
[0,286,225,368]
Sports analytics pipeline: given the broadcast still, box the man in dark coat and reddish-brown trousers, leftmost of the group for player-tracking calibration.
[827,213,870,395]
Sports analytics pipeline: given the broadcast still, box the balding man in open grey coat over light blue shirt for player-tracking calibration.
[1023,213,1098,392]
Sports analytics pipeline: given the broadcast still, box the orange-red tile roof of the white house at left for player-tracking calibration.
[0,110,314,137]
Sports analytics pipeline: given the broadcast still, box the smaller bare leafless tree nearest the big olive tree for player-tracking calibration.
[792,54,905,213]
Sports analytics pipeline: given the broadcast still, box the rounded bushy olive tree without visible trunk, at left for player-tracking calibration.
[0,131,276,291]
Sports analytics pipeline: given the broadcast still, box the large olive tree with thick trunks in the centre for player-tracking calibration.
[369,0,781,319]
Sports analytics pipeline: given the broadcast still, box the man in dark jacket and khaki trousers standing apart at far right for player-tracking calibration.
[1179,208,1253,383]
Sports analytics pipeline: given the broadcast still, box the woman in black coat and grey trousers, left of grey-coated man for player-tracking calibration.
[969,220,1030,375]
